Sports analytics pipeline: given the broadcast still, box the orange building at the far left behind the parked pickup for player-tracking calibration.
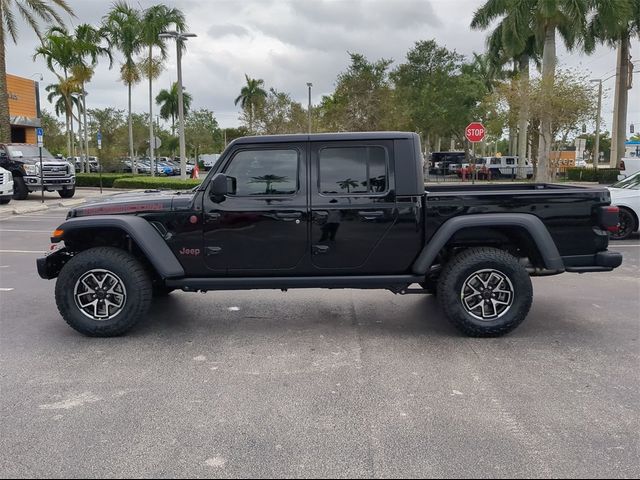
[7,74,41,143]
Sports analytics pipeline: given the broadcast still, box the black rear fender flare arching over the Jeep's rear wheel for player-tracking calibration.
[413,213,564,275]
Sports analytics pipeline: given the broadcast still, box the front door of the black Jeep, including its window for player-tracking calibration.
[203,142,309,276]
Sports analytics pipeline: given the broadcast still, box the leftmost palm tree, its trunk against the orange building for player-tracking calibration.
[0,0,74,142]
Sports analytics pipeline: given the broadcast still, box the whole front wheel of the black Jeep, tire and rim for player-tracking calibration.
[56,247,152,337]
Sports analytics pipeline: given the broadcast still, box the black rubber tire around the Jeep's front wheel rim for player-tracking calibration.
[55,247,152,337]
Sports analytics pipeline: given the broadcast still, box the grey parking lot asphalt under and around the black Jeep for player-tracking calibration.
[0,208,640,478]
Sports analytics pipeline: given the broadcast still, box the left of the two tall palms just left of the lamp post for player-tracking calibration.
[103,0,142,173]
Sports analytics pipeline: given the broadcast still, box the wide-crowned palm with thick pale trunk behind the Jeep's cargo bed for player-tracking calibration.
[474,0,595,182]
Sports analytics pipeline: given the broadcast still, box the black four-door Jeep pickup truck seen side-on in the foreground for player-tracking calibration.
[37,132,622,336]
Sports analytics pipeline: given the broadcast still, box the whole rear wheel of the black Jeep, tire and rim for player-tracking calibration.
[438,247,533,337]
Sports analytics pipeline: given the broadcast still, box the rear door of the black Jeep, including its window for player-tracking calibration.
[310,140,397,274]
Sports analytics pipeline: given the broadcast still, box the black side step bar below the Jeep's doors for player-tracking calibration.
[165,275,424,292]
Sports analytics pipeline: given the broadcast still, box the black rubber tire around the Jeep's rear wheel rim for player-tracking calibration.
[438,247,533,337]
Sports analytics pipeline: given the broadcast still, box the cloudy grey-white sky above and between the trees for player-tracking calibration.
[7,0,640,135]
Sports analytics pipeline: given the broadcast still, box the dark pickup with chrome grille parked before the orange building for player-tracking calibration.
[0,143,76,200]
